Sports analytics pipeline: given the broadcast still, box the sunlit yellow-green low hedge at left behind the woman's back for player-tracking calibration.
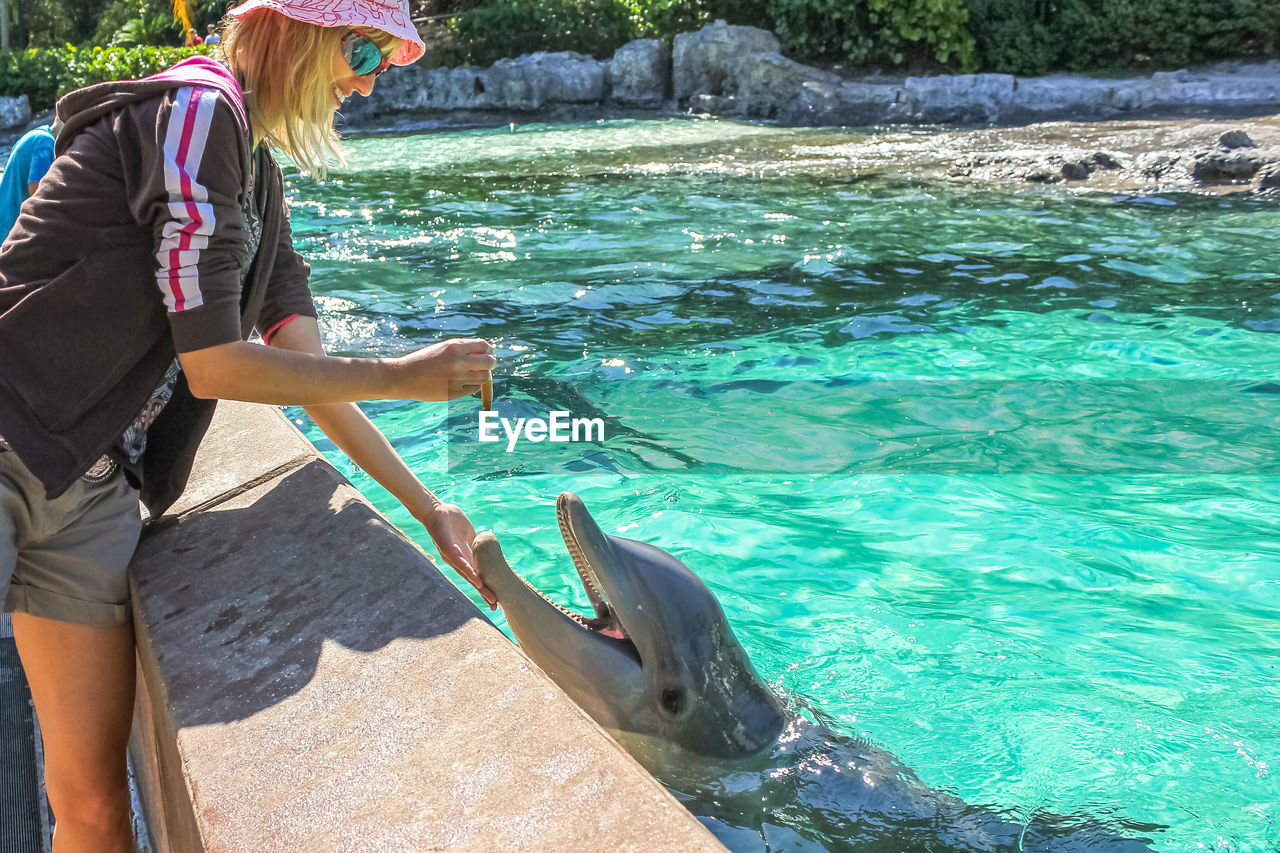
[0,45,207,111]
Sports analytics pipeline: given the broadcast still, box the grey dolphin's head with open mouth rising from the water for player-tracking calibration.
[474,492,786,758]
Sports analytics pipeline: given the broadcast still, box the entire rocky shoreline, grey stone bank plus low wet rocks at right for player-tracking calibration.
[0,22,1280,196]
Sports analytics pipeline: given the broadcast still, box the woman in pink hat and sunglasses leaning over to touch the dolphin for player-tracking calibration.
[0,0,494,853]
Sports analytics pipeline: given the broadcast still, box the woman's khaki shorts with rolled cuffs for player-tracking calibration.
[0,442,142,625]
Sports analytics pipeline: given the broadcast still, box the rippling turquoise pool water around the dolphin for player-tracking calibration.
[289,122,1280,852]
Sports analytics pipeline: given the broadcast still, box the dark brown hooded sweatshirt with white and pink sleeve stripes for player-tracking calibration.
[0,56,315,517]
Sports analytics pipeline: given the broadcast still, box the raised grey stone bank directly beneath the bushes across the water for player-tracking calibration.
[344,20,1280,128]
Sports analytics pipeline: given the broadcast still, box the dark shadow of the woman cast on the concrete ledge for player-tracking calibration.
[134,461,490,725]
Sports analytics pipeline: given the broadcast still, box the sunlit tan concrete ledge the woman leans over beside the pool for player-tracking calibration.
[131,403,723,853]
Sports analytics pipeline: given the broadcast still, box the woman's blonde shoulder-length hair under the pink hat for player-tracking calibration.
[221,9,398,178]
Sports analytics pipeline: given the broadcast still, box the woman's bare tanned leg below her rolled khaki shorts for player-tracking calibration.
[13,613,134,853]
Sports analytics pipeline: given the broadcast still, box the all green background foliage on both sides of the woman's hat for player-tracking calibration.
[0,0,1280,81]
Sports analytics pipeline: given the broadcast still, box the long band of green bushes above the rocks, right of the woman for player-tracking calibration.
[443,0,1280,76]
